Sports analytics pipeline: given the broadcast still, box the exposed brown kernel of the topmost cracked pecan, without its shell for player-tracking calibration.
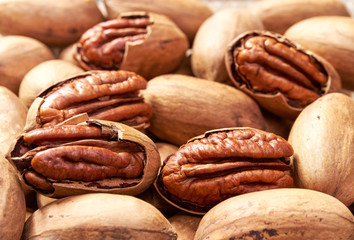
[74,15,153,70]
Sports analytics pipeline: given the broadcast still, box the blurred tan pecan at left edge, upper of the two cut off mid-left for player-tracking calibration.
[0,35,54,95]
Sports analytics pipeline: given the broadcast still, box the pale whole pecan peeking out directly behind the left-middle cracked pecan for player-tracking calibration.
[18,59,84,107]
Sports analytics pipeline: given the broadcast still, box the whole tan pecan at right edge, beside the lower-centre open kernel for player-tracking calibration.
[289,93,354,206]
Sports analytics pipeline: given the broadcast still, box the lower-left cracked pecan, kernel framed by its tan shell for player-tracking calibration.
[7,120,161,197]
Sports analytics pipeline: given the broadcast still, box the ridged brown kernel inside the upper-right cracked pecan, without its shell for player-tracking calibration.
[232,32,328,108]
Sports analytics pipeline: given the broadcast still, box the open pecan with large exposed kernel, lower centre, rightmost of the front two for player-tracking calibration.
[156,128,293,214]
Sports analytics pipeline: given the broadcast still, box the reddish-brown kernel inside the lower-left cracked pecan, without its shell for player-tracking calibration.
[15,125,145,191]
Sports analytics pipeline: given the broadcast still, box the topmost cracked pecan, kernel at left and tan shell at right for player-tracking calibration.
[74,12,189,79]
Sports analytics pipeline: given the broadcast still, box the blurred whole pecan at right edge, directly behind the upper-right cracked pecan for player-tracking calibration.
[284,16,354,90]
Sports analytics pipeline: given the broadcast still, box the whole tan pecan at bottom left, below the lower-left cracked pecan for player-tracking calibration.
[22,193,177,240]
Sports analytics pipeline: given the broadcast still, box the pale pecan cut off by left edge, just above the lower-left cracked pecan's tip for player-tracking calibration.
[0,86,27,155]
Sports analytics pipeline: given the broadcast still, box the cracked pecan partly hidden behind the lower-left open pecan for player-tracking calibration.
[26,70,153,131]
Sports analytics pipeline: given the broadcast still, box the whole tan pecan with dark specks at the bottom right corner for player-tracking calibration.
[194,188,354,240]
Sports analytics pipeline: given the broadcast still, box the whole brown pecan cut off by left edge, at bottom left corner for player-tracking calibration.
[0,154,26,240]
